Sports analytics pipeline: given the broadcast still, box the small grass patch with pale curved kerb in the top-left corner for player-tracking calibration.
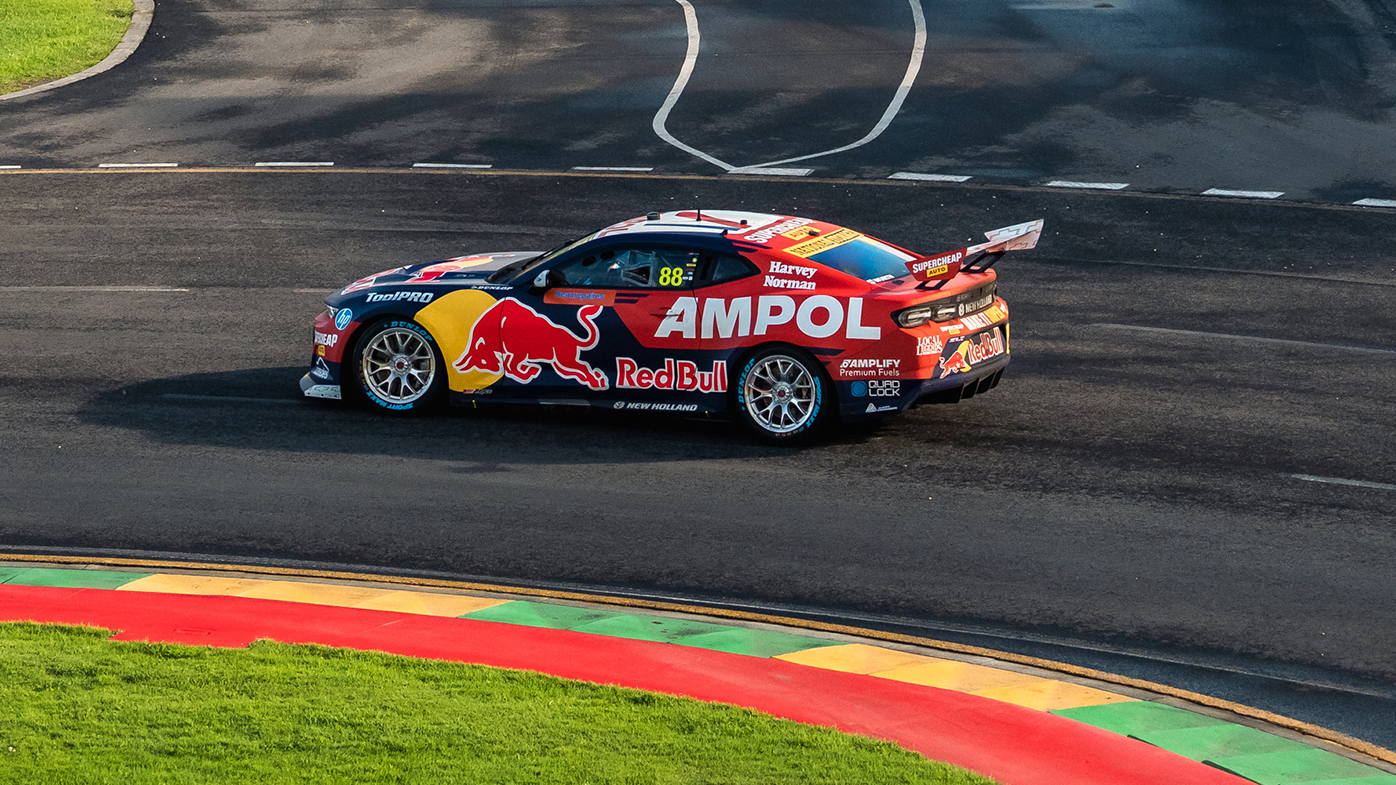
[0,0,135,95]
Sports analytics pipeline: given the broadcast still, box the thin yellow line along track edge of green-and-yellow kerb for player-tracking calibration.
[0,550,1396,764]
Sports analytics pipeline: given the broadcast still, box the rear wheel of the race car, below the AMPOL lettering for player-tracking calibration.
[732,345,838,444]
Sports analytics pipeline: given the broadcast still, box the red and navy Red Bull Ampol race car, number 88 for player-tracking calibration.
[308,211,1043,441]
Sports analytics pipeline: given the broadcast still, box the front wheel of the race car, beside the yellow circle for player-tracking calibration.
[350,317,447,415]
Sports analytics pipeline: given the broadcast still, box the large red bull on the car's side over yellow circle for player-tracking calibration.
[455,298,607,390]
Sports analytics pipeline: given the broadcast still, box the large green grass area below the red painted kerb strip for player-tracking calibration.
[0,623,991,785]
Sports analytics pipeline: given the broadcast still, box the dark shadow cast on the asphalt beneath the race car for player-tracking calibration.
[78,366,877,460]
